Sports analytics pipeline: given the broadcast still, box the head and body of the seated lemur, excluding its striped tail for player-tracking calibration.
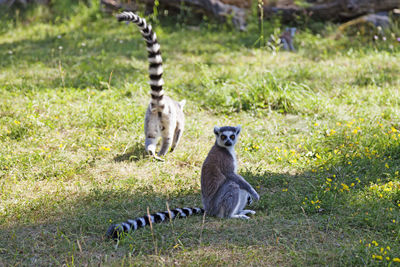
[201,125,260,219]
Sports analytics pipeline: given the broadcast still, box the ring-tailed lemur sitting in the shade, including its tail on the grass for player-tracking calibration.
[106,126,260,239]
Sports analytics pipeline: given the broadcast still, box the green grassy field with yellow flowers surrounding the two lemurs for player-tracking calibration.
[0,1,400,266]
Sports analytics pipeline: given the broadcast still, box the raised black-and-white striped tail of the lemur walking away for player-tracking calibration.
[117,11,164,106]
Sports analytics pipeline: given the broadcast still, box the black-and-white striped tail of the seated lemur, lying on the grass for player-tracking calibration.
[106,208,204,239]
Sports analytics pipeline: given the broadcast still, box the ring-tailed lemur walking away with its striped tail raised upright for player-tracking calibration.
[117,12,186,159]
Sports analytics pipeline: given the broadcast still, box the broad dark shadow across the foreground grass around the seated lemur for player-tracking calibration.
[0,137,400,265]
